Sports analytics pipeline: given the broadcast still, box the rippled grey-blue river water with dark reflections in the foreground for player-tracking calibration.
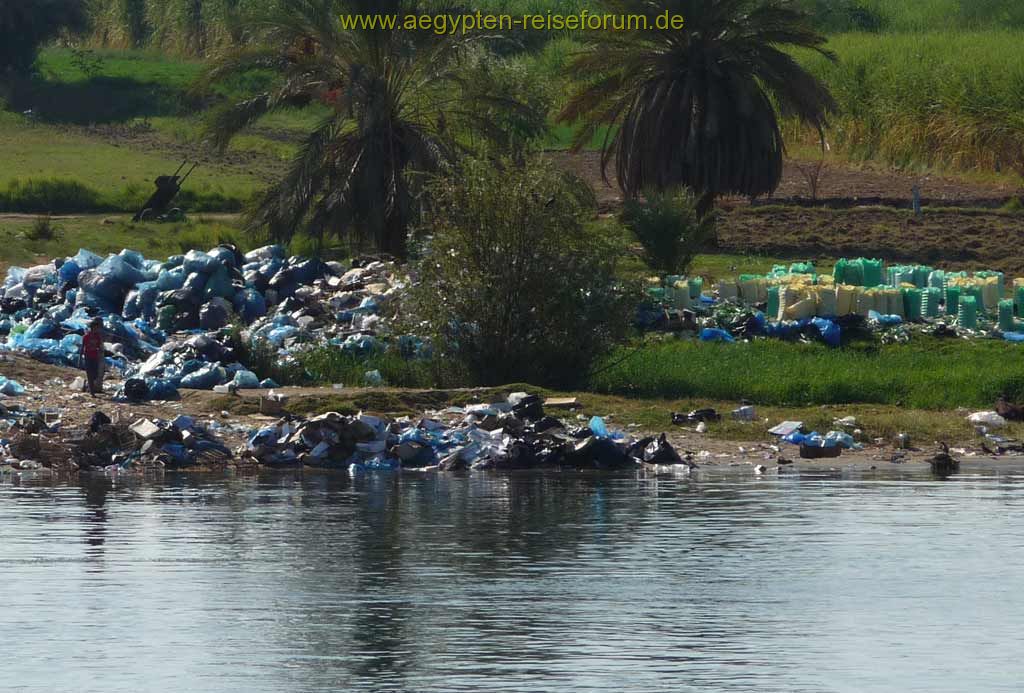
[0,470,1024,693]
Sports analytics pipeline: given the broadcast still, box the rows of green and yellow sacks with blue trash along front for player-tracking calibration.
[637,258,1024,347]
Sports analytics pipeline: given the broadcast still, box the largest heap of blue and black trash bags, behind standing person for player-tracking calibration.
[0,245,415,399]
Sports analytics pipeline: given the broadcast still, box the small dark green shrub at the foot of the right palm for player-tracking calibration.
[622,189,715,274]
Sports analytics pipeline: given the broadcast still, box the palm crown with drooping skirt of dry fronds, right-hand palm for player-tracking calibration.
[558,0,837,216]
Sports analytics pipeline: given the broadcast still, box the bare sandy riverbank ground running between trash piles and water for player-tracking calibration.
[4,356,1007,476]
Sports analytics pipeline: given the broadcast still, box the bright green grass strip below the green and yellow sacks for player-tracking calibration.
[592,336,1024,410]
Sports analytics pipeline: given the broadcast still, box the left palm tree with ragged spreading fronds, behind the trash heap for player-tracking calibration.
[204,0,528,257]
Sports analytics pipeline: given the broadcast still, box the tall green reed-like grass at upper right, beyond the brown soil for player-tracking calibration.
[799,30,1024,175]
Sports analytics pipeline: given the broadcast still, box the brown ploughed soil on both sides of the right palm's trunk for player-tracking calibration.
[549,151,1024,276]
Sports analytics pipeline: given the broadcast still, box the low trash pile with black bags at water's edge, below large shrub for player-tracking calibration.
[240,393,695,473]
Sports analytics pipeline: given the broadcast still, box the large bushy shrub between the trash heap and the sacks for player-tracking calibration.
[411,153,633,386]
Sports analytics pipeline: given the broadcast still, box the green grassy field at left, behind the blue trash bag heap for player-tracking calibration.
[0,48,309,213]
